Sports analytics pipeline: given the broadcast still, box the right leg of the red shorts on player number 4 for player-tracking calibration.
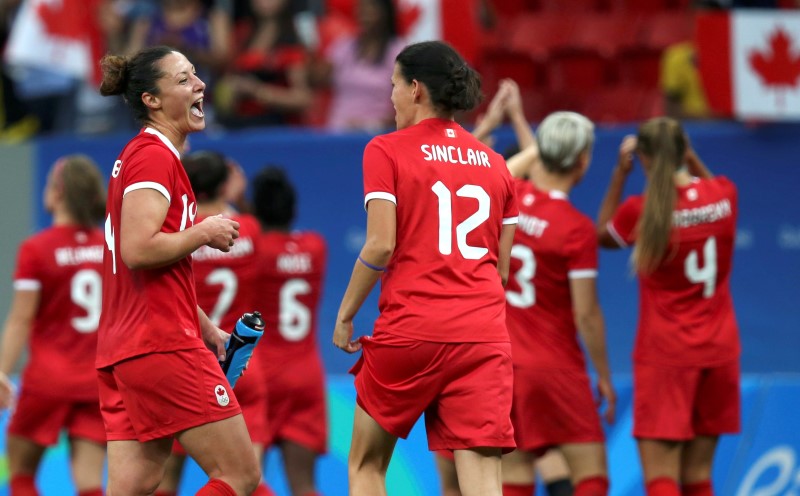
[692,360,741,436]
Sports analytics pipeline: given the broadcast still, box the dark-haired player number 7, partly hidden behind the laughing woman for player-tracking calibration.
[156,151,273,496]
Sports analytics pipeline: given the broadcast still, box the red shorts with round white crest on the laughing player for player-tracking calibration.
[97,349,241,442]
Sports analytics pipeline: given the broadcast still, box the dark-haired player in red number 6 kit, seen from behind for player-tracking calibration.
[247,167,328,496]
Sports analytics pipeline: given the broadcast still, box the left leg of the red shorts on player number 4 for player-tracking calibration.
[633,362,700,441]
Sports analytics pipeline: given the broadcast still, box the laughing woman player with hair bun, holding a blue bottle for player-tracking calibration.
[97,46,260,495]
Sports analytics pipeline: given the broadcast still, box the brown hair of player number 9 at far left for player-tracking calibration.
[57,155,106,227]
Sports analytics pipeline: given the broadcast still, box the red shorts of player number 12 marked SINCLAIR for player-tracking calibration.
[351,333,516,451]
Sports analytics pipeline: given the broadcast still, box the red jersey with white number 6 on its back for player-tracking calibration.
[256,231,328,358]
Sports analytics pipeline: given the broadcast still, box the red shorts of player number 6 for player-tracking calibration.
[263,353,328,453]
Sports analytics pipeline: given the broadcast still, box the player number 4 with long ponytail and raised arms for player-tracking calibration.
[597,118,740,496]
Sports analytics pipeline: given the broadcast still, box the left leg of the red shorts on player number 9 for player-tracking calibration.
[8,387,71,446]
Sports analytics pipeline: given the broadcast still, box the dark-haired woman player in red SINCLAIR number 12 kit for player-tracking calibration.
[333,41,517,496]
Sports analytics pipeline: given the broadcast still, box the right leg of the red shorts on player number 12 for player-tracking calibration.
[425,343,516,452]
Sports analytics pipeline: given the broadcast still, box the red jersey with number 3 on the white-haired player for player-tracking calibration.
[506,180,597,371]
